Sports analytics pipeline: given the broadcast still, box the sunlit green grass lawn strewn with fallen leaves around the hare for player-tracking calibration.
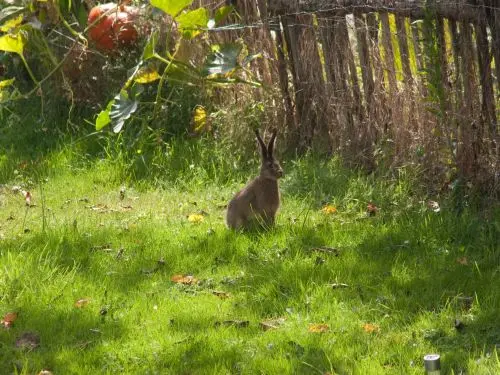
[0,141,500,374]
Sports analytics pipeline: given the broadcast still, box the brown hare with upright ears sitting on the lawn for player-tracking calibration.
[226,130,283,229]
